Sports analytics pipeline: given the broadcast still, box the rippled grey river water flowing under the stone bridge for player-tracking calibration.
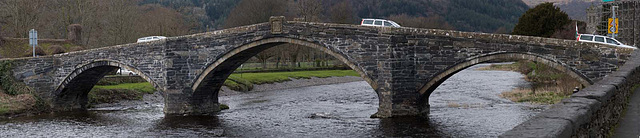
[0,64,545,137]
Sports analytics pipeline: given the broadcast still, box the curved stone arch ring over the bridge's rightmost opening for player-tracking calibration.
[419,52,593,98]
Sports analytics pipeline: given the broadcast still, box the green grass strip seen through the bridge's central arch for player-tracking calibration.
[229,70,360,84]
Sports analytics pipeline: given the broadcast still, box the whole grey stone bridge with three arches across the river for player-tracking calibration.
[6,17,633,117]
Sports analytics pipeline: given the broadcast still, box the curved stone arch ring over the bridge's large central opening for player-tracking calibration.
[191,37,378,100]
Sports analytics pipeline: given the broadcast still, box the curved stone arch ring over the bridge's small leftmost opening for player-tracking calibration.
[53,59,159,110]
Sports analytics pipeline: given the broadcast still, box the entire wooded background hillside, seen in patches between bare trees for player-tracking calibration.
[146,0,528,32]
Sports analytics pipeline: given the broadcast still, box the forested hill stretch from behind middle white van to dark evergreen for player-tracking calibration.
[354,0,529,33]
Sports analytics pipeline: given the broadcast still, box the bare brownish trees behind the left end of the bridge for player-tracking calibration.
[0,0,196,48]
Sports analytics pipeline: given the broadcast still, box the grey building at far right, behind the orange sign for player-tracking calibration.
[587,0,640,47]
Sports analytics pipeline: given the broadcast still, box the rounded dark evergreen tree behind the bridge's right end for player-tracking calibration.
[512,2,571,37]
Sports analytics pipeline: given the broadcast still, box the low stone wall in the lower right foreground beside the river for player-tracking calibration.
[500,51,640,138]
